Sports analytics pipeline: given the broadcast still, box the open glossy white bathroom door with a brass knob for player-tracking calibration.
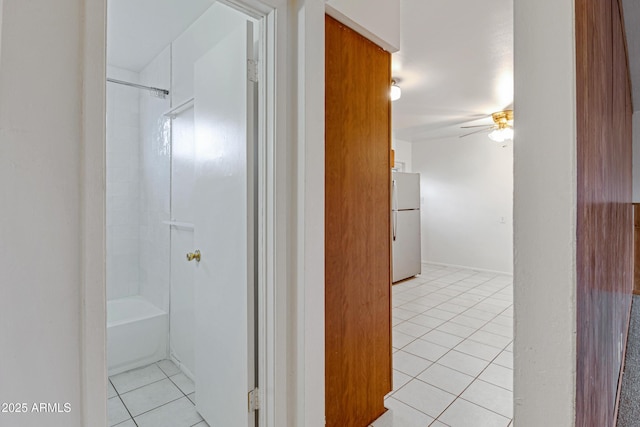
[194,18,255,427]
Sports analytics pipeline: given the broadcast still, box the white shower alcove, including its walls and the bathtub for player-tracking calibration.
[107,47,171,375]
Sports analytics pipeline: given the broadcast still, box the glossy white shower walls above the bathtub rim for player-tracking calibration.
[107,52,171,311]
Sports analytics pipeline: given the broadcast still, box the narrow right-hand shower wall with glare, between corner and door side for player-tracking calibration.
[138,46,171,312]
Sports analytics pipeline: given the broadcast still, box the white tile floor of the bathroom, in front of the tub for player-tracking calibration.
[107,360,209,427]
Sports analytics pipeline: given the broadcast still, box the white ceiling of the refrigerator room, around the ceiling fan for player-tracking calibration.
[392,0,516,141]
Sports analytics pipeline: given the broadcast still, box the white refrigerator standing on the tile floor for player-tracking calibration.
[391,172,422,283]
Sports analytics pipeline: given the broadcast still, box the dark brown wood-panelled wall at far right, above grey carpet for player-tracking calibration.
[576,0,633,427]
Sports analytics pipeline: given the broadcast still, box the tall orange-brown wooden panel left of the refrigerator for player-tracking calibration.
[325,16,392,427]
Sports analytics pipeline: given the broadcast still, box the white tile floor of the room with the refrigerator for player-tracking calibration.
[372,264,513,427]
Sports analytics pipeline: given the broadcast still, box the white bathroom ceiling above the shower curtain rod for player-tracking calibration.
[107,0,215,71]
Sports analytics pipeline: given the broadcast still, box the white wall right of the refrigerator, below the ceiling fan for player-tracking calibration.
[412,134,513,273]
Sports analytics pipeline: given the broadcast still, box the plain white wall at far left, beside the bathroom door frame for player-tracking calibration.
[0,0,84,427]
